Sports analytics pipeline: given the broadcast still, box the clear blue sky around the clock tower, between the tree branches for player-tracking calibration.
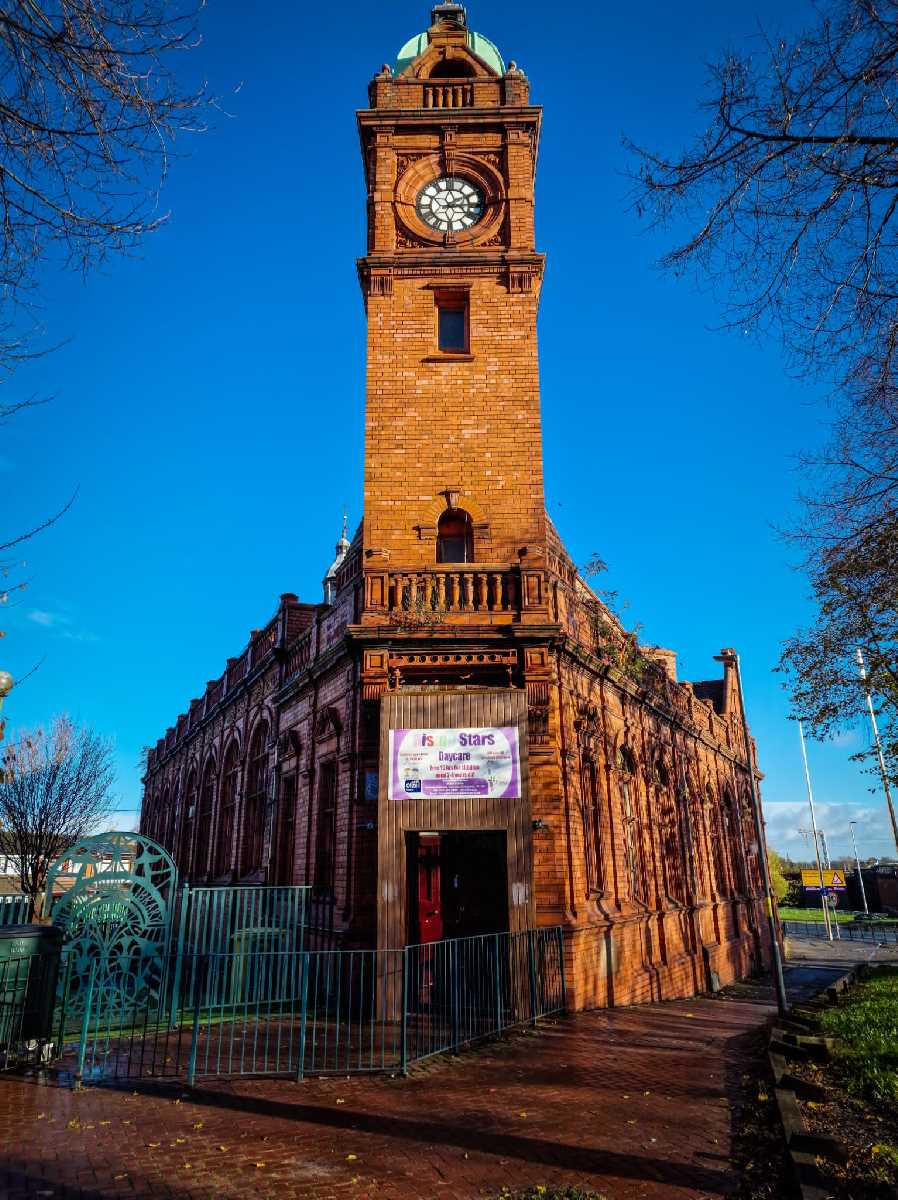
[0,0,894,854]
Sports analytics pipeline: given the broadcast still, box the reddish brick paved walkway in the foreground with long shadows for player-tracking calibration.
[0,968,854,1200]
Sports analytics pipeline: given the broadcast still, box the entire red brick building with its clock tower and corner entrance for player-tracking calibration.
[142,4,766,1006]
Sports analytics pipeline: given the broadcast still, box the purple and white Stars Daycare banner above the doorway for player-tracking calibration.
[389,728,521,800]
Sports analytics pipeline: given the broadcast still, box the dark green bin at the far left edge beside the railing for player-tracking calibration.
[0,925,62,1048]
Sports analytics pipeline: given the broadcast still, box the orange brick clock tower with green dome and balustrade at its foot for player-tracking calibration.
[358,4,546,626]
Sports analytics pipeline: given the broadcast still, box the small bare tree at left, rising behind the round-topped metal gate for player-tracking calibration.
[0,716,115,917]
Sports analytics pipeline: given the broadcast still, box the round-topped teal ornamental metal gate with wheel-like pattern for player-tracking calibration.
[47,833,178,1021]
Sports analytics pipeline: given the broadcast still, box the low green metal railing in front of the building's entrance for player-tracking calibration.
[58,929,565,1084]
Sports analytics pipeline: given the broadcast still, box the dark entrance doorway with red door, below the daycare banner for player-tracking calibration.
[406,829,508,944]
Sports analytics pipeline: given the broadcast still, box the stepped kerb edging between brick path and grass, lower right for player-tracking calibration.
[767,962,870,1200]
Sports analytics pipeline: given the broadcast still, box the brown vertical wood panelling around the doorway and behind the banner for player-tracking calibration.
[377,688,534,949]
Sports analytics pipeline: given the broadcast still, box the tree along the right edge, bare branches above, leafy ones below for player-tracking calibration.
[630,0,898,778]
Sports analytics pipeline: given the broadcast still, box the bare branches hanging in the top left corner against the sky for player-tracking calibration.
[0,0,205,362]
